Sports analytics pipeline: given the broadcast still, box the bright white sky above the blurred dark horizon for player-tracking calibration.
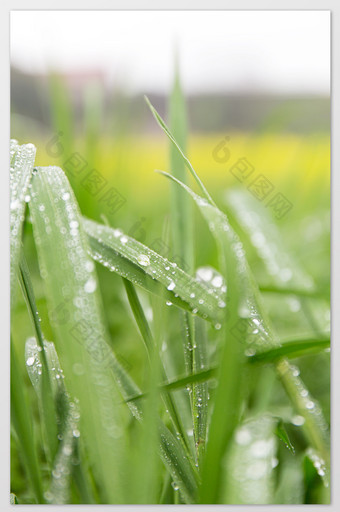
[11,11,330,94]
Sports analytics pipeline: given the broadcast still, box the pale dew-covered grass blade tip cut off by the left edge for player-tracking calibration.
[10,140,36,306]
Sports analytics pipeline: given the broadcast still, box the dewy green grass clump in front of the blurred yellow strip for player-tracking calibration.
[10,72,330,504]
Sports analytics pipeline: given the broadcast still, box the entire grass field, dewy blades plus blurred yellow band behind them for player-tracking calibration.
[11,76,330,504]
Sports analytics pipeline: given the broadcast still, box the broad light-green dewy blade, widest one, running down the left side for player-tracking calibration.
[30,167,128,503]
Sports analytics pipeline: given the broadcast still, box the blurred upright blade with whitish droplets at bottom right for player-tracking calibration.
[221,415,277,505]
